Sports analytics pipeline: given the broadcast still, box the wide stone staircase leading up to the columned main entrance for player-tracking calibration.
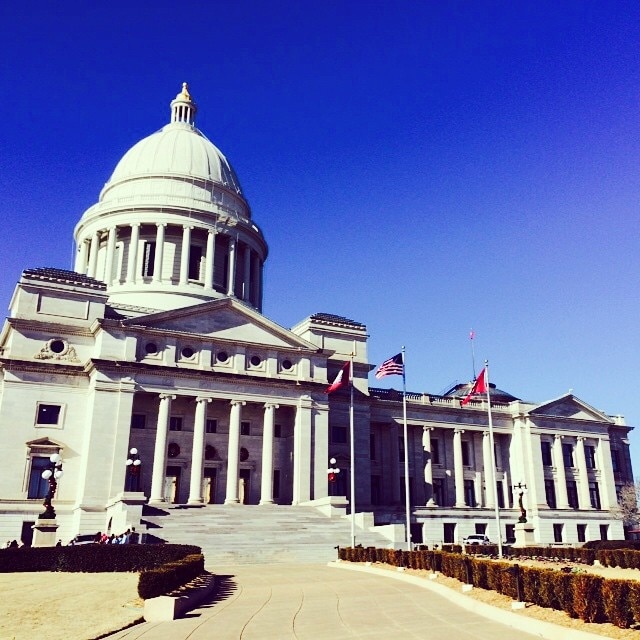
[142,505,389,568]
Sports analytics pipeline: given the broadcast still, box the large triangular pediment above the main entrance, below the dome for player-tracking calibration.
[122,298,318,351]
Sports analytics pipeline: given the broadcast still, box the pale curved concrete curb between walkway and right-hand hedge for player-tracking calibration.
[327,560,604,640]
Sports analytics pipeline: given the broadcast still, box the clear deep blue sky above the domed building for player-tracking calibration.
[0,0,640,464]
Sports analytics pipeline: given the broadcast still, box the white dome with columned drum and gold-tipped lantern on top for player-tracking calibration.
[74,83,268,310]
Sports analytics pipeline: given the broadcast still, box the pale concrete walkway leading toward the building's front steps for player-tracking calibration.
[102,565,540,640]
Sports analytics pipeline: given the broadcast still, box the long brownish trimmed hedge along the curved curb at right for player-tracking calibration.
[338,547,640,628]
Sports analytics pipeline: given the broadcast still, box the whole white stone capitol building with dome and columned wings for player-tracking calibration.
[0,84,633,544]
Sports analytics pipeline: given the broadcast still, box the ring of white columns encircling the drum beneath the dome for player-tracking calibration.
[75,222,263,308]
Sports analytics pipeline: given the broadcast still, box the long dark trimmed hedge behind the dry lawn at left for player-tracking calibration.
[0,544,201,573]
